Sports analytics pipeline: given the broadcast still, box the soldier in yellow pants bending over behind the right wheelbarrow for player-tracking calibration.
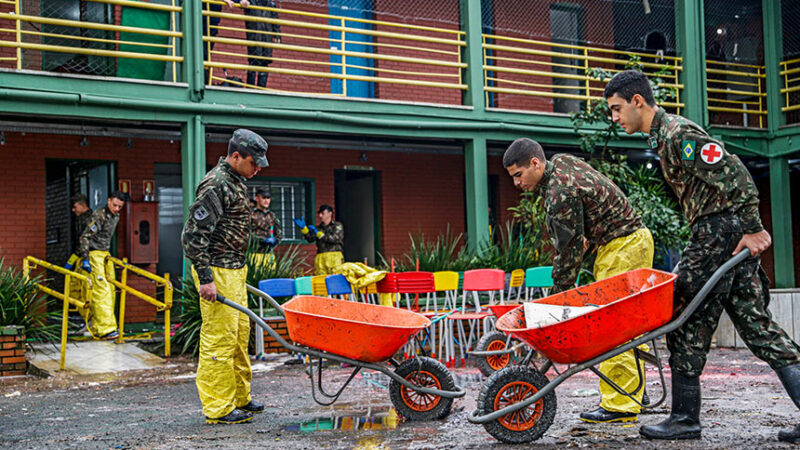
[503,138,653,423]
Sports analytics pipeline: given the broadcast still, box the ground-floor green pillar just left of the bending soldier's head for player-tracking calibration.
[464,138,489,250]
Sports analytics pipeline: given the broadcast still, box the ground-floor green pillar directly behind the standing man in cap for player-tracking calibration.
[181,116,206,278]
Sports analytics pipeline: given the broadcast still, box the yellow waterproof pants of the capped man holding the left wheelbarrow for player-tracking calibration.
[192,266,252,419]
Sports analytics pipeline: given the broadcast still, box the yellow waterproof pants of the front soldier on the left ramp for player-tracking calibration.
[89,250,117,338]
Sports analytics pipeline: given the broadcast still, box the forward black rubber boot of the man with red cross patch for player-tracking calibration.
[639,372,701,440]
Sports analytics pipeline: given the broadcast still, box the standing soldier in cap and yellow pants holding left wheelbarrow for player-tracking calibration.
[181,129,269,424]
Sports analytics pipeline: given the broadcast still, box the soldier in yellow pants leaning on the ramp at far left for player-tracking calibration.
[78,191,127,339]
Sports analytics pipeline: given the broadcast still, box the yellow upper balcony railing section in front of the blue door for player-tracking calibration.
[203,0,467,96]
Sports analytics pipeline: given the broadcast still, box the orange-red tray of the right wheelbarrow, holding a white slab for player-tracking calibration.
[495,269,677,364]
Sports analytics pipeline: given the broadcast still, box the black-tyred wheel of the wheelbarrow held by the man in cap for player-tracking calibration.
[389,356,456,420]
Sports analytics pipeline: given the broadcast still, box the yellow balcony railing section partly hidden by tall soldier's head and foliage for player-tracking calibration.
[483,34,683,113]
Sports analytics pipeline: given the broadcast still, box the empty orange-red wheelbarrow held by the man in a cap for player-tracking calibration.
[218,285,465,420]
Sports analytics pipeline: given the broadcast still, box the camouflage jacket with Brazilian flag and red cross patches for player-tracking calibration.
[649,108,764,234]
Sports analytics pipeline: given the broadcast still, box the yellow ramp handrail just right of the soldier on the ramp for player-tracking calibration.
[106,256,173,357]
